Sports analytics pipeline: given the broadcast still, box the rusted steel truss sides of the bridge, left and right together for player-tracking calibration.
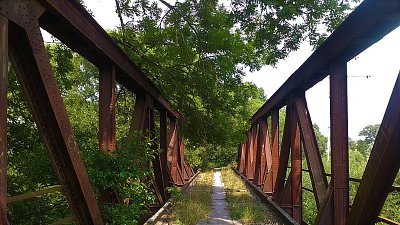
[0,0,400,224]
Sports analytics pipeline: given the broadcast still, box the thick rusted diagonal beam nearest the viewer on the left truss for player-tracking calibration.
[9,1,103,224]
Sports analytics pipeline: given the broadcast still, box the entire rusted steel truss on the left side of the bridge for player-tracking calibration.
[0,0,194,224]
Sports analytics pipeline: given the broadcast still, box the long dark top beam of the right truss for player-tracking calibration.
[251,0,400,124]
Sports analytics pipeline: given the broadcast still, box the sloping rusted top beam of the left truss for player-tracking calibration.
[32,0,180,118]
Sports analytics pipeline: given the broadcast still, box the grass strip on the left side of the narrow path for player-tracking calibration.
[172,171,213,225]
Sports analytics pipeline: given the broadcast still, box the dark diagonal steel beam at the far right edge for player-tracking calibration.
[347,74,400,224]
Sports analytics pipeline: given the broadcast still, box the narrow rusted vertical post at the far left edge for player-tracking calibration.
[0,15,8,224]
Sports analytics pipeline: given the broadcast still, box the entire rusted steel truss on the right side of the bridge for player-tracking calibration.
[237,0,400,225]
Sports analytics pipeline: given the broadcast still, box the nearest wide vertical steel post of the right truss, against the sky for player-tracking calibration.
[330,62,349,225]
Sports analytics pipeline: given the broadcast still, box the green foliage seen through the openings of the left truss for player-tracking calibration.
[7,44,158,224]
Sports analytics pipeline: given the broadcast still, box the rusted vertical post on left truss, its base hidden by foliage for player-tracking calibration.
[99,66,116,152]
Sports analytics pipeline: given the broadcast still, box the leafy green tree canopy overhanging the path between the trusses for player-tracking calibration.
[109,0,356,167]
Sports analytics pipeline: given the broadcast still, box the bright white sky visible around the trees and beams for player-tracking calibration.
[77,0,400,140]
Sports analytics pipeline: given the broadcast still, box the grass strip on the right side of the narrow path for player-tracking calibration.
[221,168,282,224]
